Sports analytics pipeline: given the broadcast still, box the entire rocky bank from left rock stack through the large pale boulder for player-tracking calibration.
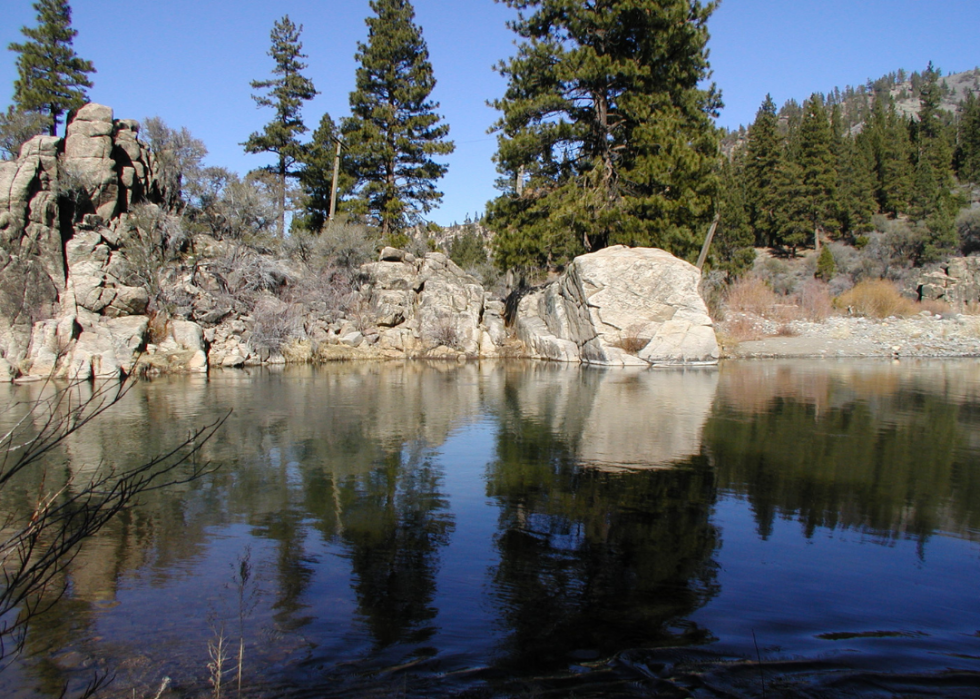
[0,104,718,380]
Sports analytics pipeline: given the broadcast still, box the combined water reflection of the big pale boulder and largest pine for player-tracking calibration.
[487,368,719,672]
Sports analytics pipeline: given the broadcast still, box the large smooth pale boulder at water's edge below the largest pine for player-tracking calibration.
[516,246,719,366]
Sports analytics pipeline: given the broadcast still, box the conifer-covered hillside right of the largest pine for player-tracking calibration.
[718,64,980,273]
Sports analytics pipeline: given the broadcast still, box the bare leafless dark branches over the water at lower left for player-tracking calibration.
[0,381,227,659]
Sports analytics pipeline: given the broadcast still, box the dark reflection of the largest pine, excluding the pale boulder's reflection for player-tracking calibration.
[488,379,718,671]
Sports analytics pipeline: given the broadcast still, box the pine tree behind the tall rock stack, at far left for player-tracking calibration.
[8,0,95,136]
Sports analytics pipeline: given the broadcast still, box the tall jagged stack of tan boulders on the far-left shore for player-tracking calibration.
[0,104,206,380]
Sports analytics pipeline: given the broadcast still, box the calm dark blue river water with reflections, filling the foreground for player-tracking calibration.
[0,361,980,697]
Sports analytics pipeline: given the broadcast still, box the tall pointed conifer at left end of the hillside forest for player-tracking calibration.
[745,95,782,246]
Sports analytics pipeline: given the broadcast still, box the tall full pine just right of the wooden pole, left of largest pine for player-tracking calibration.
[341,0,455,237]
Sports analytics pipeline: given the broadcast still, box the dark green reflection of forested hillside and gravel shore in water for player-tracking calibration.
[705,361,980,546]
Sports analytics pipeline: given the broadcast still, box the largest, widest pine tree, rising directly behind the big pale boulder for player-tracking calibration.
[488,0,721,268]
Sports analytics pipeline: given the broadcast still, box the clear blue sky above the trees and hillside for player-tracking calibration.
[0,0,980,224]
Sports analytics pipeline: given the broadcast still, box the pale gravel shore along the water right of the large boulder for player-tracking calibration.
[717,312,980,358]
